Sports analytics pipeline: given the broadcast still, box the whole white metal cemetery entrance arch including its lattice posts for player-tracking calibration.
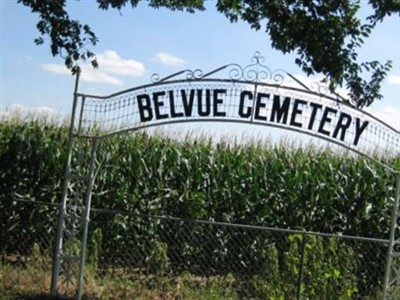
[51,52,400,299]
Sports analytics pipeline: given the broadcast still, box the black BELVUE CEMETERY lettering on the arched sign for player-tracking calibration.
[136,89,369,146]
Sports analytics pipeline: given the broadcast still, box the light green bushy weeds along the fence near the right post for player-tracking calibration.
[250,234,358,300]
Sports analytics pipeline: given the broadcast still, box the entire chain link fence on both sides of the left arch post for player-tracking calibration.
[0,201,388,299]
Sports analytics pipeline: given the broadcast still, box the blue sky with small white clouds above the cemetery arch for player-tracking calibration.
[0,0,400,142]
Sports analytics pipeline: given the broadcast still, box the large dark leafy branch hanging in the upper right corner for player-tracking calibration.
[217,0,400,108]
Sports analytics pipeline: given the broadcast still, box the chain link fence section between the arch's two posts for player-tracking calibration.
[89,207,387,299]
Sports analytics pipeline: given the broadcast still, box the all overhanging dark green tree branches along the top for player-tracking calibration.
[18,0,400,108]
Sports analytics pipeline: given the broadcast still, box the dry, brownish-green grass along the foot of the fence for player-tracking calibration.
[0,262,238,300]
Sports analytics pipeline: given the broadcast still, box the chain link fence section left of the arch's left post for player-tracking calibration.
[0,199,58,299]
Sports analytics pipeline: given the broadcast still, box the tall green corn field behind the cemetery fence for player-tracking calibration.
[0,121,399,299]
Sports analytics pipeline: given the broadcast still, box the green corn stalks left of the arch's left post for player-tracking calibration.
[0,122,67,255]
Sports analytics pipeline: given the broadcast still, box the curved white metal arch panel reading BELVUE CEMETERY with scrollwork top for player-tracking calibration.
[78,53,400,159]
